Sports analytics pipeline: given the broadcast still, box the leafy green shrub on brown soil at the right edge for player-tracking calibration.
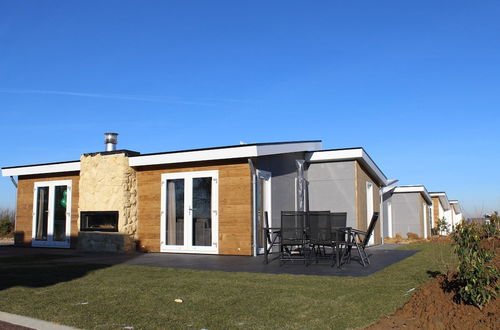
[452,223,499,308]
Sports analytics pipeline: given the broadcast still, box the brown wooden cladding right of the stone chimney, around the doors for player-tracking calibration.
[137,160,252,255]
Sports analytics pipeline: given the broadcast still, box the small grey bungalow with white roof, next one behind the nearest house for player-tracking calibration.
[384,185,432,238]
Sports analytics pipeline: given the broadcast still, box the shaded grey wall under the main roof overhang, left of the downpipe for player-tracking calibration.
[253,152,304,227]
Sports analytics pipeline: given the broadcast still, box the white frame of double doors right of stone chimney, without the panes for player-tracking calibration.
[160,170,219,254]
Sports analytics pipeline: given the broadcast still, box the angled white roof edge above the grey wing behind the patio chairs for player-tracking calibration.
[306,148,387,187]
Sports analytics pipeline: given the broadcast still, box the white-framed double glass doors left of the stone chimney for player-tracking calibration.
[31,180,71,248]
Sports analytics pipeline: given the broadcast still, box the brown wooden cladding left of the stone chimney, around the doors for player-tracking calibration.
[14,172,80,247]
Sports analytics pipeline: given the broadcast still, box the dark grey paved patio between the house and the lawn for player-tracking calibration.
[0,244,418,276]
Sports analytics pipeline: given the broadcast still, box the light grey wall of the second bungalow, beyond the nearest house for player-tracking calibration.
[391,193,423,237]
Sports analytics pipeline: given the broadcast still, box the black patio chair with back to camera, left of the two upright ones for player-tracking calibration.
[279,211,308,265]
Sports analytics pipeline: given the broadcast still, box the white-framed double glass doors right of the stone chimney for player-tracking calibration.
[160,171,218,253]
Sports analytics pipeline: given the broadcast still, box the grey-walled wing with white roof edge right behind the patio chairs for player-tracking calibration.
[306,148,388,244]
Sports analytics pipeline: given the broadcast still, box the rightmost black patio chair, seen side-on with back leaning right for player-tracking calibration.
[340,212,379,267]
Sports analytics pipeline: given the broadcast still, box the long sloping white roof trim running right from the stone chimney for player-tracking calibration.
[129,142,321,167]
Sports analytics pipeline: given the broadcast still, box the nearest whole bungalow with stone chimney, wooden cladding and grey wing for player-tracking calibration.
[2,134,387,255]
